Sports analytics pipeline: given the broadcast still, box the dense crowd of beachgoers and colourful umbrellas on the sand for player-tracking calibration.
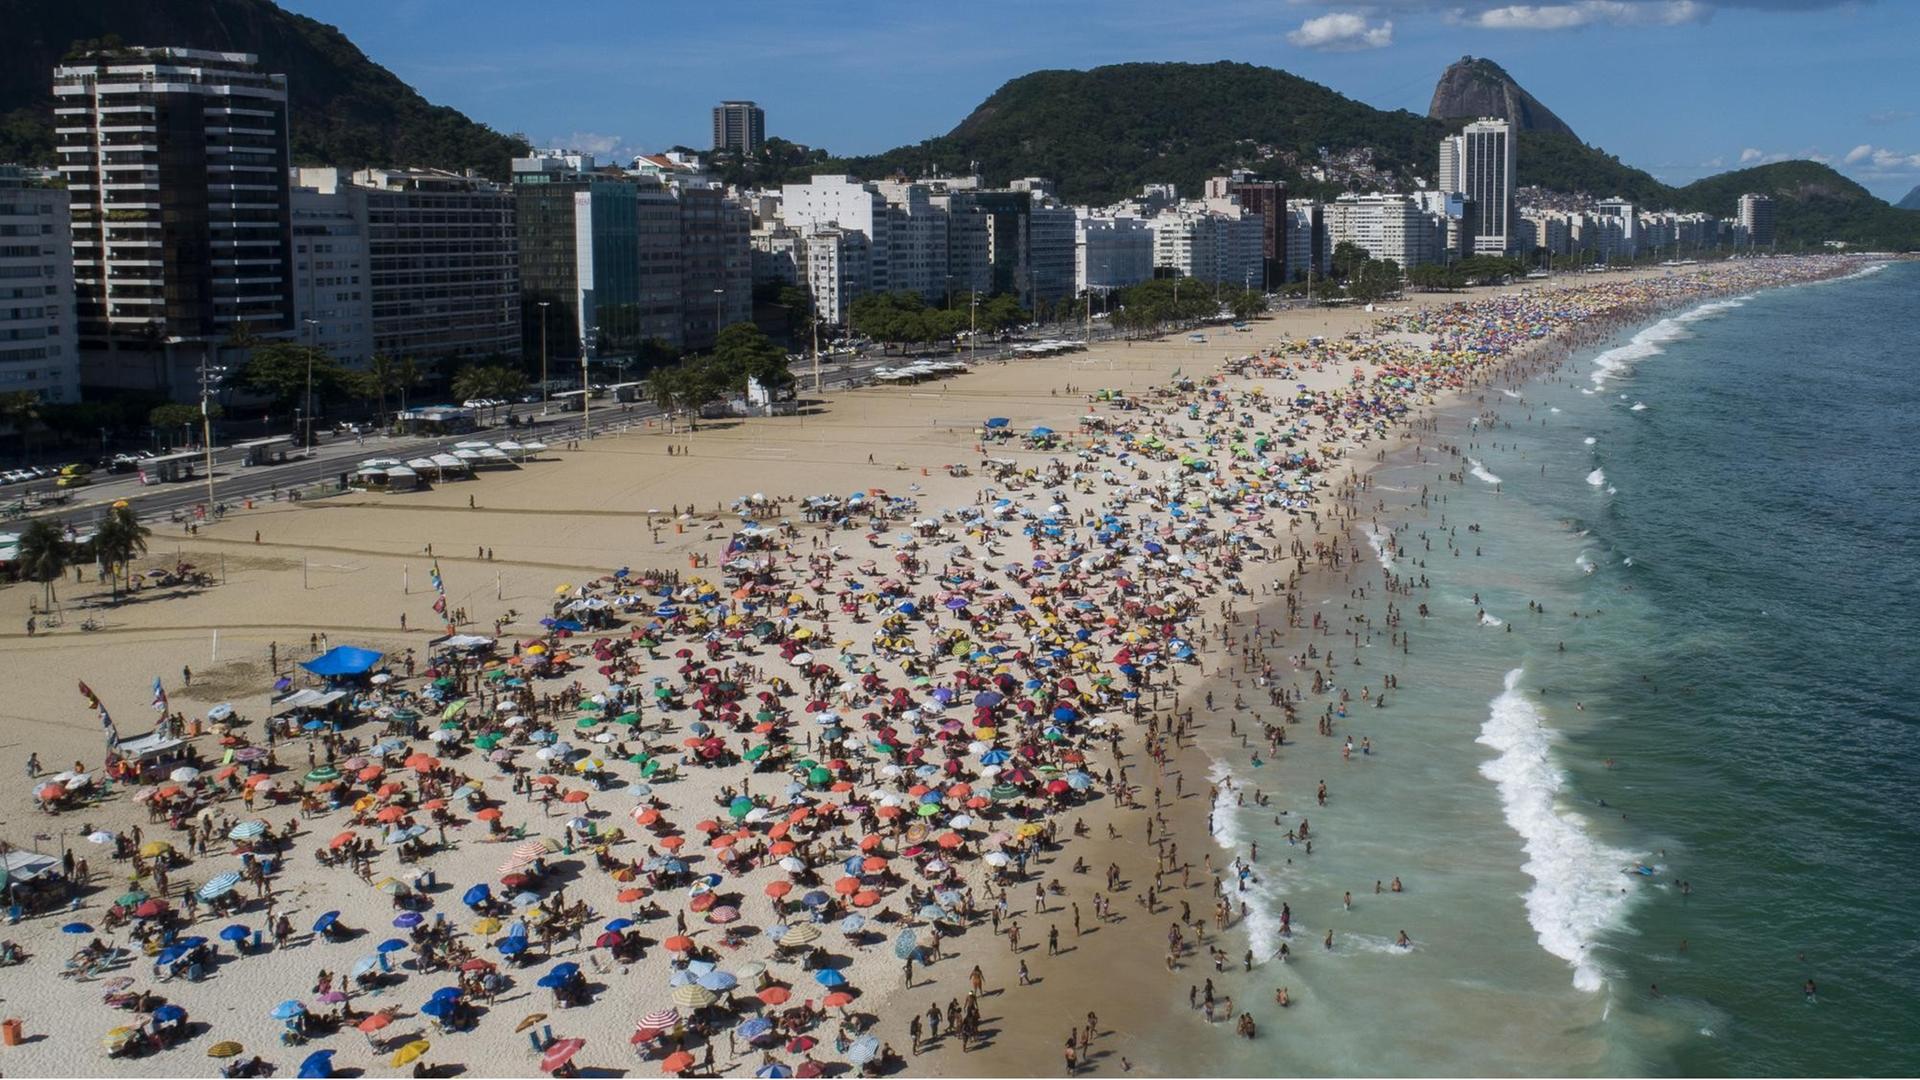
[0,251,1866,1076]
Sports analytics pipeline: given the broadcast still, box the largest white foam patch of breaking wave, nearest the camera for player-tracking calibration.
[1478,669,1632,990]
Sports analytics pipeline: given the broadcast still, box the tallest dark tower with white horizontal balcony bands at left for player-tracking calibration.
[54,46,294,398]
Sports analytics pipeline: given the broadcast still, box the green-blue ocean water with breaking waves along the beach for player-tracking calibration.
[1171,263,1920,1076]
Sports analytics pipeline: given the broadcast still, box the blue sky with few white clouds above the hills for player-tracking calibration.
[278,0,1920,200]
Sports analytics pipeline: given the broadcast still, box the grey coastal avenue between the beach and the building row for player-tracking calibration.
[0,331,1110,532]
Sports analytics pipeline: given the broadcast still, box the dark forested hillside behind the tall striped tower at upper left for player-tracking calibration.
[0,0,526,179]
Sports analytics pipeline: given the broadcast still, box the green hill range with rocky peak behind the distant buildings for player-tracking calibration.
[829,61,1920,248]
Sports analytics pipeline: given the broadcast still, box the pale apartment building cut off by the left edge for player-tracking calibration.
[0,165,81,402]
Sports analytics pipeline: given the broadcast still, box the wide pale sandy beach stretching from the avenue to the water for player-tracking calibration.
[0,259,1847,1076]
